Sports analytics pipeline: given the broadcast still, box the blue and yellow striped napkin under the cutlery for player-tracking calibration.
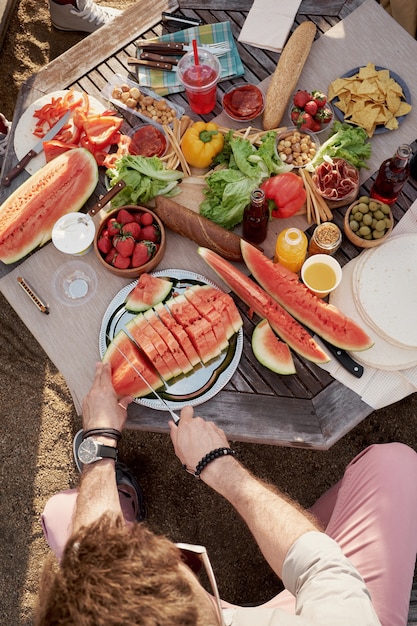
[137,22,245,96]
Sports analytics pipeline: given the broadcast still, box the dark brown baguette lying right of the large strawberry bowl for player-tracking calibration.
[153,196,242,261]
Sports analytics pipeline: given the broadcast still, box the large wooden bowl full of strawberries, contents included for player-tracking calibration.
[94,205,166,278]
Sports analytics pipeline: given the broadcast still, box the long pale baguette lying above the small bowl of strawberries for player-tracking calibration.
[263,22,317,130]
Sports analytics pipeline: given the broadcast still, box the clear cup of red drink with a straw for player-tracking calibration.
[177,48,221,115]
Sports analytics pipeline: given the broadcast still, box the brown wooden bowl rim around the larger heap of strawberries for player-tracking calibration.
[94,205,166,279]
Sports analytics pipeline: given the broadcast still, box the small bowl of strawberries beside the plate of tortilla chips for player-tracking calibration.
[288,89,334,133]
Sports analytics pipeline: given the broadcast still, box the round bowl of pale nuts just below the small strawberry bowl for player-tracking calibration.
[275,126,320,167]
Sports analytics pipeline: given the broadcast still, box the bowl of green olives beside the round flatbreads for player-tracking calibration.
[344,196,394,248]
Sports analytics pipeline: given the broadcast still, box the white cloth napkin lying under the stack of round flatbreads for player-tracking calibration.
[316,200,417,409]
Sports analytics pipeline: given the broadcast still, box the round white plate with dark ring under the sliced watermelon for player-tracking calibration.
[99,269,243,411]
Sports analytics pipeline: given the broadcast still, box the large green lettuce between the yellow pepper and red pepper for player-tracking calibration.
[200,131,292,230]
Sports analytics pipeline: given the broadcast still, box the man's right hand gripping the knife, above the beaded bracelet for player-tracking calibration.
[169,406,230,478]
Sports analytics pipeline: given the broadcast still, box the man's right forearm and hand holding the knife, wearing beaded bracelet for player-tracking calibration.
[170,407,318,578]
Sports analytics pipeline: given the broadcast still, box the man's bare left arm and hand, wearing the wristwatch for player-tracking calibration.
[73,363,132,531]
